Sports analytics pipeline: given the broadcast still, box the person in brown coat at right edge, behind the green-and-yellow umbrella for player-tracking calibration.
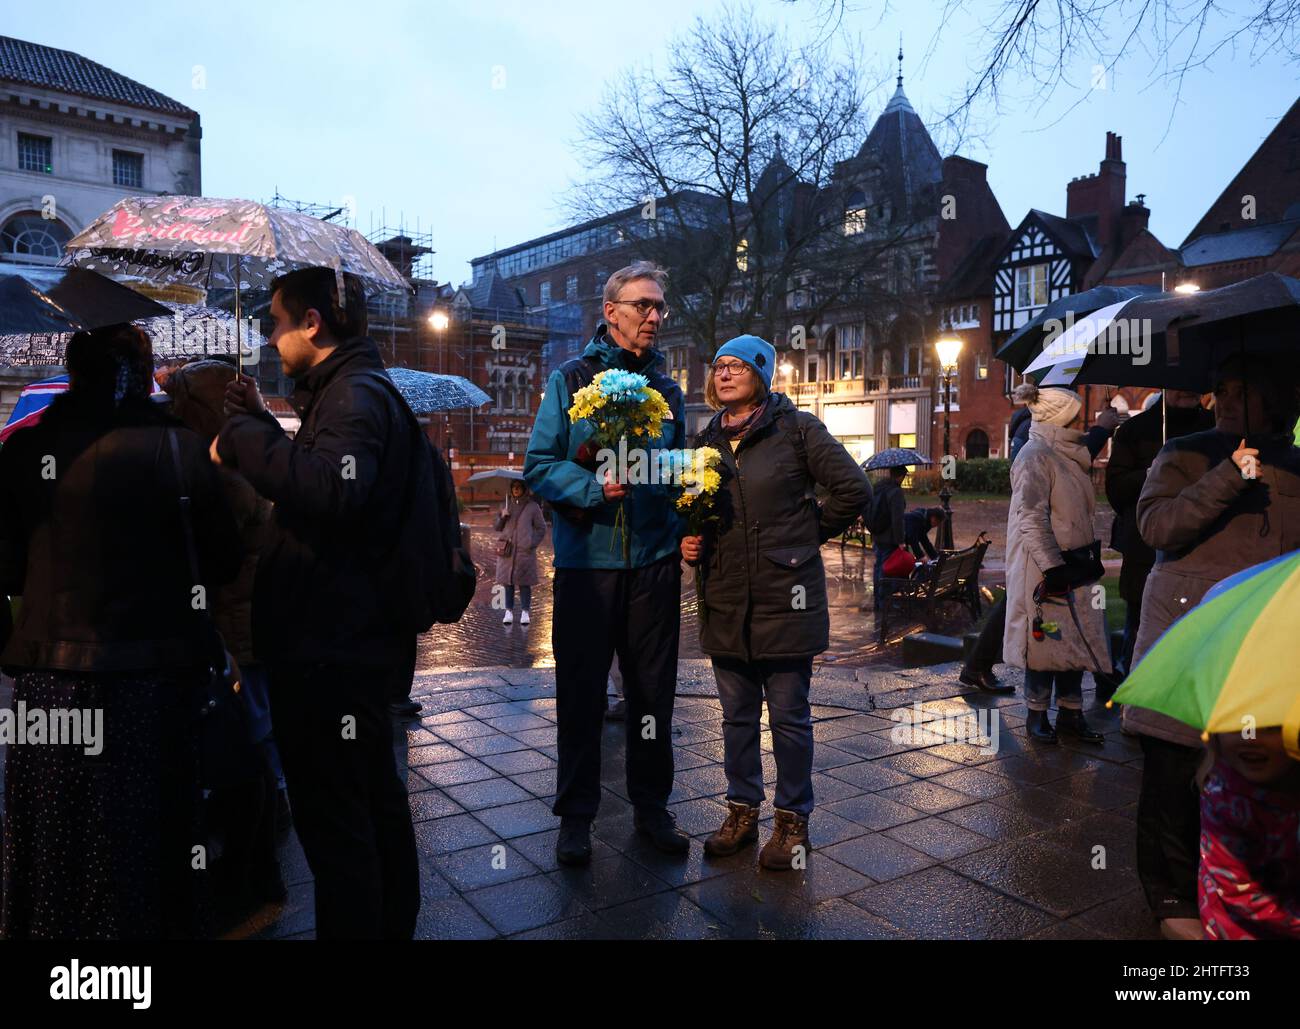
[1123,359,1300,938]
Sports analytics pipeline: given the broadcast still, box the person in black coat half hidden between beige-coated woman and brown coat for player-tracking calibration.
[1104,390,1214,680]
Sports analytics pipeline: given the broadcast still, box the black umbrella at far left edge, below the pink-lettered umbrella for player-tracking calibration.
[0,268,172,335]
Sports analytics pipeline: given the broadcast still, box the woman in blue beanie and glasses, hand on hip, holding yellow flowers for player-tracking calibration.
[681,335,871,869]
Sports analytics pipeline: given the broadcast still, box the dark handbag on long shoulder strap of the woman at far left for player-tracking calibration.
[166,429,252,790]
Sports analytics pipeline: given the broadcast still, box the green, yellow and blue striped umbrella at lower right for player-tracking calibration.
[1108,551,1300,759]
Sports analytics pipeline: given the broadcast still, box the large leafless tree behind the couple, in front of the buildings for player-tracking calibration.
[571,6,935,359]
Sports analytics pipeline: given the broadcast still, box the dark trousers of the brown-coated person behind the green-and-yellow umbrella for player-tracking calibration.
[1138,735,1201,919]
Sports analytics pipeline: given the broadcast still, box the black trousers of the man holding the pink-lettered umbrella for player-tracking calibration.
[270,664,420,939]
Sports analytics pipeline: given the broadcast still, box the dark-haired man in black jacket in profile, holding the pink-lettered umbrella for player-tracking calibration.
[212,268,420,939]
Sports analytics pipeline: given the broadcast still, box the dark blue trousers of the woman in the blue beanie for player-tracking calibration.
[714,657,813,817]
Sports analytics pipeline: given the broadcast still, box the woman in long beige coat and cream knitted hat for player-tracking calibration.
[1002,383,1110,743]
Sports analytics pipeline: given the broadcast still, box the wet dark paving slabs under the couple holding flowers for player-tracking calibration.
[255,660,1158,939]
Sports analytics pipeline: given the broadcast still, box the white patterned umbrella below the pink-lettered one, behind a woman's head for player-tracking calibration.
[0,300,267,366]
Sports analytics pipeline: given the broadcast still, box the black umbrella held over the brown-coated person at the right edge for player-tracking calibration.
[1074,272,1300,392]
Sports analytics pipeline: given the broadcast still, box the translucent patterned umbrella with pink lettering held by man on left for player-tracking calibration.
[66,196,410,294]
